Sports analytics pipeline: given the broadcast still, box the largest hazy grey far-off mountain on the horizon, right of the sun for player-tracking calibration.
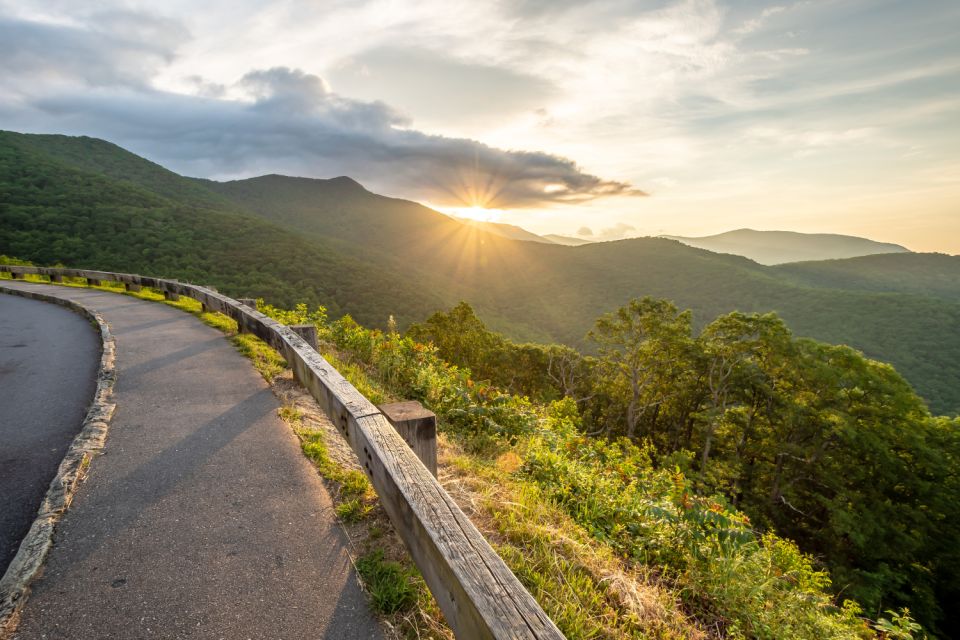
[660,229,909,265]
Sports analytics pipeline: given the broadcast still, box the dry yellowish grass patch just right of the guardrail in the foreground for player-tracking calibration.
[440,440,709,639]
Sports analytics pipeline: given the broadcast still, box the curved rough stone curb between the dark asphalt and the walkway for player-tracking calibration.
[0,284,117,640]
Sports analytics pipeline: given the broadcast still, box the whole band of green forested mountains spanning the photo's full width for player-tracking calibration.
[0,132,960,413]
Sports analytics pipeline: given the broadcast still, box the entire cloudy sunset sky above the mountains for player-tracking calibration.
[0,0,960,254]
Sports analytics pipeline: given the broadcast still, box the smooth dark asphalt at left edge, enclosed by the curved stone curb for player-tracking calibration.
[0,295,100,575]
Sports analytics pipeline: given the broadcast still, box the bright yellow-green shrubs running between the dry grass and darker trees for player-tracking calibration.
[292,298,900,638]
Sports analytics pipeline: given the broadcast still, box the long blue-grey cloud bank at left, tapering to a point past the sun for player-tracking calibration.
[0,14,641,208]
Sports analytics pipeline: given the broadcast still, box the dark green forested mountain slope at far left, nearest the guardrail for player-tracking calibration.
[0,132,446,323]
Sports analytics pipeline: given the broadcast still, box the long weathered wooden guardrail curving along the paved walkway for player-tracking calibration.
[0,265,563,640]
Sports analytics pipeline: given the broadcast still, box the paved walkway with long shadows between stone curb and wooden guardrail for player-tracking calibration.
[0,283,382,640]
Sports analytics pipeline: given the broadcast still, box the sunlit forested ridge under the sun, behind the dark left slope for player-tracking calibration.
[213,170,960,413]
